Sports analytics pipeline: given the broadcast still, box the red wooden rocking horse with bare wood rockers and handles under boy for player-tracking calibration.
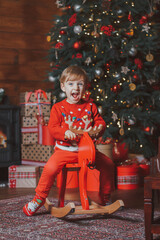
[44,127,124,218]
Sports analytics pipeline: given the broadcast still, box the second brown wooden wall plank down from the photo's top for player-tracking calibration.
[0,15,52,35]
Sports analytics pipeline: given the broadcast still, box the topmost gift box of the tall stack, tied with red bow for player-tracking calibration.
[20,90,51,116]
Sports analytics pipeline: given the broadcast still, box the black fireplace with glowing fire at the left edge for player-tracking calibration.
[0,105,21,167]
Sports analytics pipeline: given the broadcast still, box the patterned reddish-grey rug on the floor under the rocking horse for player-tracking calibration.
[0,195,158,240]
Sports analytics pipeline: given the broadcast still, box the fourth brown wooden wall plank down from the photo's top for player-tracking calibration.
[0,48,49,65]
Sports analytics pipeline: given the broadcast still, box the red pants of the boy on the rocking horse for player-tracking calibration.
[35,148,114,204]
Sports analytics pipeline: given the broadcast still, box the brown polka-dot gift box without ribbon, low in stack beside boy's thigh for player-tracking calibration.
[21,144,54,162]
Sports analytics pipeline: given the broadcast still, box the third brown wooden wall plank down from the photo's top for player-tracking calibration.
[0,32,50,50]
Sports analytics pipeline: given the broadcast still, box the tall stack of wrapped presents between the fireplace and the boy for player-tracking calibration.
[8,89,54,188]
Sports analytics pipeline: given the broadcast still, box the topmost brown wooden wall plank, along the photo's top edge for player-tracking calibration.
[0,0,60,20]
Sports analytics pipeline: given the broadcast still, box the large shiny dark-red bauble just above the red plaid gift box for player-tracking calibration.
[112,142,128,162]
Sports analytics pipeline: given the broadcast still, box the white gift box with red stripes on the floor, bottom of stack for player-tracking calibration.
[8,165,39,188]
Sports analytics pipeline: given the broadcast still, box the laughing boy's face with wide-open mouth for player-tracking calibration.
[61,78,85,104]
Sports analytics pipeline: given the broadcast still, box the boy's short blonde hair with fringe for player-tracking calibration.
[60,66,88,84]
